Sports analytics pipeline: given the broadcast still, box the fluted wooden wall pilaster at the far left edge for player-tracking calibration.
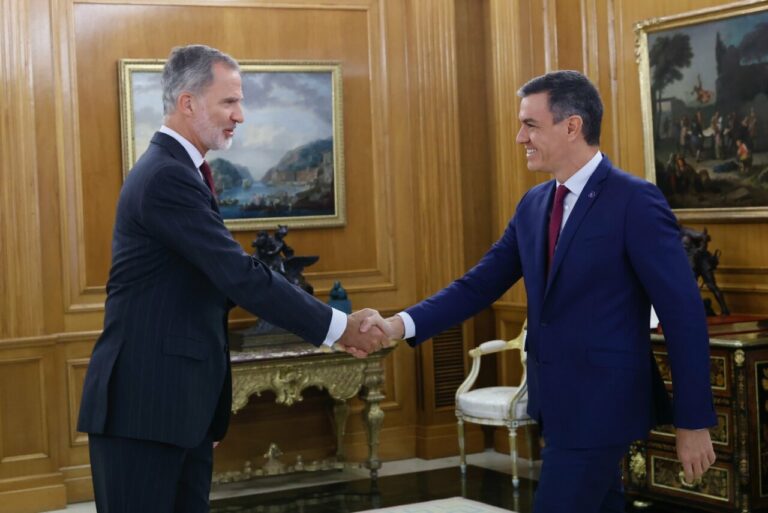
[0,0,44,339]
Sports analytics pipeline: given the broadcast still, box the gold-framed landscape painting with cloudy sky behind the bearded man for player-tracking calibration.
[118,59,346,231]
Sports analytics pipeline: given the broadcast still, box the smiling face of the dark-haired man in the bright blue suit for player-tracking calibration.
[516,92,571,174]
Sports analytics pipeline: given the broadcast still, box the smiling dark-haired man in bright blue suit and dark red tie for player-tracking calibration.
[362,71,716,513]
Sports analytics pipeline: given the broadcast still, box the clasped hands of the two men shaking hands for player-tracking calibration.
[335,308,405,358]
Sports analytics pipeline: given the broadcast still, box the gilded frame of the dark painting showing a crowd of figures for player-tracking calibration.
[634,0,768,221]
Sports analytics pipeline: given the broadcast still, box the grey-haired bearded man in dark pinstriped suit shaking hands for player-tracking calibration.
[78,45,384,513]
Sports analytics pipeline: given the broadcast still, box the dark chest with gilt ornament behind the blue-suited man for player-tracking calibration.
[625,321,768,513]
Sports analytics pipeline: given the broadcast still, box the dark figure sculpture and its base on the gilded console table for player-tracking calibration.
[230,225,320,350]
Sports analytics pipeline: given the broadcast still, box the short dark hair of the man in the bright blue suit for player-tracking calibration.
[517,70,603,146]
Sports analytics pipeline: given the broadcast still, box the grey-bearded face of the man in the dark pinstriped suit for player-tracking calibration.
[190,63,243,155]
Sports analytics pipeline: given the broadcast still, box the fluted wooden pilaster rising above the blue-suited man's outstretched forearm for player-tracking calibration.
[408,0,464,296]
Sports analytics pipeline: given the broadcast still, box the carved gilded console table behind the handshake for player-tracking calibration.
[214,343,393,483]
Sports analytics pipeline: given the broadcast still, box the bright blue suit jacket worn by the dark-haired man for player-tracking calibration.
[407,157,715,448]
